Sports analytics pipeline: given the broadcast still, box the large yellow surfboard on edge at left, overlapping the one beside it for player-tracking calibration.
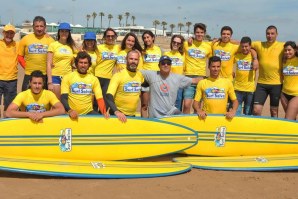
[0,116,197,160]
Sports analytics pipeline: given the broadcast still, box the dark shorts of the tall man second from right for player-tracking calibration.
[254,83,282,107]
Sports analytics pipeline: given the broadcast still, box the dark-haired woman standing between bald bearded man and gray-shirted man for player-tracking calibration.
[141,30,162,117]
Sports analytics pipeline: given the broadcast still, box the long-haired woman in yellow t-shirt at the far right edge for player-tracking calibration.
[281,41,298,120]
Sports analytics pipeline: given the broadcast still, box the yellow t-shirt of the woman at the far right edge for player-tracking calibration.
[282,57,298,96]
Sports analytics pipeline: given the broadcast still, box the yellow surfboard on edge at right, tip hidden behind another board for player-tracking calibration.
[161,115,298,156]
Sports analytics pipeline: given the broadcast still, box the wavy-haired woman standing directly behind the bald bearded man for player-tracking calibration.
[116,32,143,71]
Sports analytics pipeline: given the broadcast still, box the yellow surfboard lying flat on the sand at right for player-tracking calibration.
[174,154,298,171]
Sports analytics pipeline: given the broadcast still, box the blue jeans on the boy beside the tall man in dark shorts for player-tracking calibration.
[235,91,254,115]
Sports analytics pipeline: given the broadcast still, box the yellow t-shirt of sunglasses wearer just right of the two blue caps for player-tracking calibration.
[95,44,120,79]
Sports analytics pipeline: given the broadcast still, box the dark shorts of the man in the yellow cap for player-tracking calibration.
[0,80,18,111]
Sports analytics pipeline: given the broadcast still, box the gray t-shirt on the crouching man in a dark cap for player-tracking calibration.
[141,70,192,117]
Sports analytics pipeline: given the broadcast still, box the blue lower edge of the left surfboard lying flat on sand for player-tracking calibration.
[0,166,192,178]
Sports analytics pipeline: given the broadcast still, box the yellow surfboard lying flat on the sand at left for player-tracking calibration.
[0,156,191,178]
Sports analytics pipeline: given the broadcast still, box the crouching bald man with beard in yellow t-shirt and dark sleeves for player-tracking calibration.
[107,50,144,122]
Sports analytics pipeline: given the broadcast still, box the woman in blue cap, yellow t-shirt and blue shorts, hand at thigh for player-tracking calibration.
[47,23,76,99]
